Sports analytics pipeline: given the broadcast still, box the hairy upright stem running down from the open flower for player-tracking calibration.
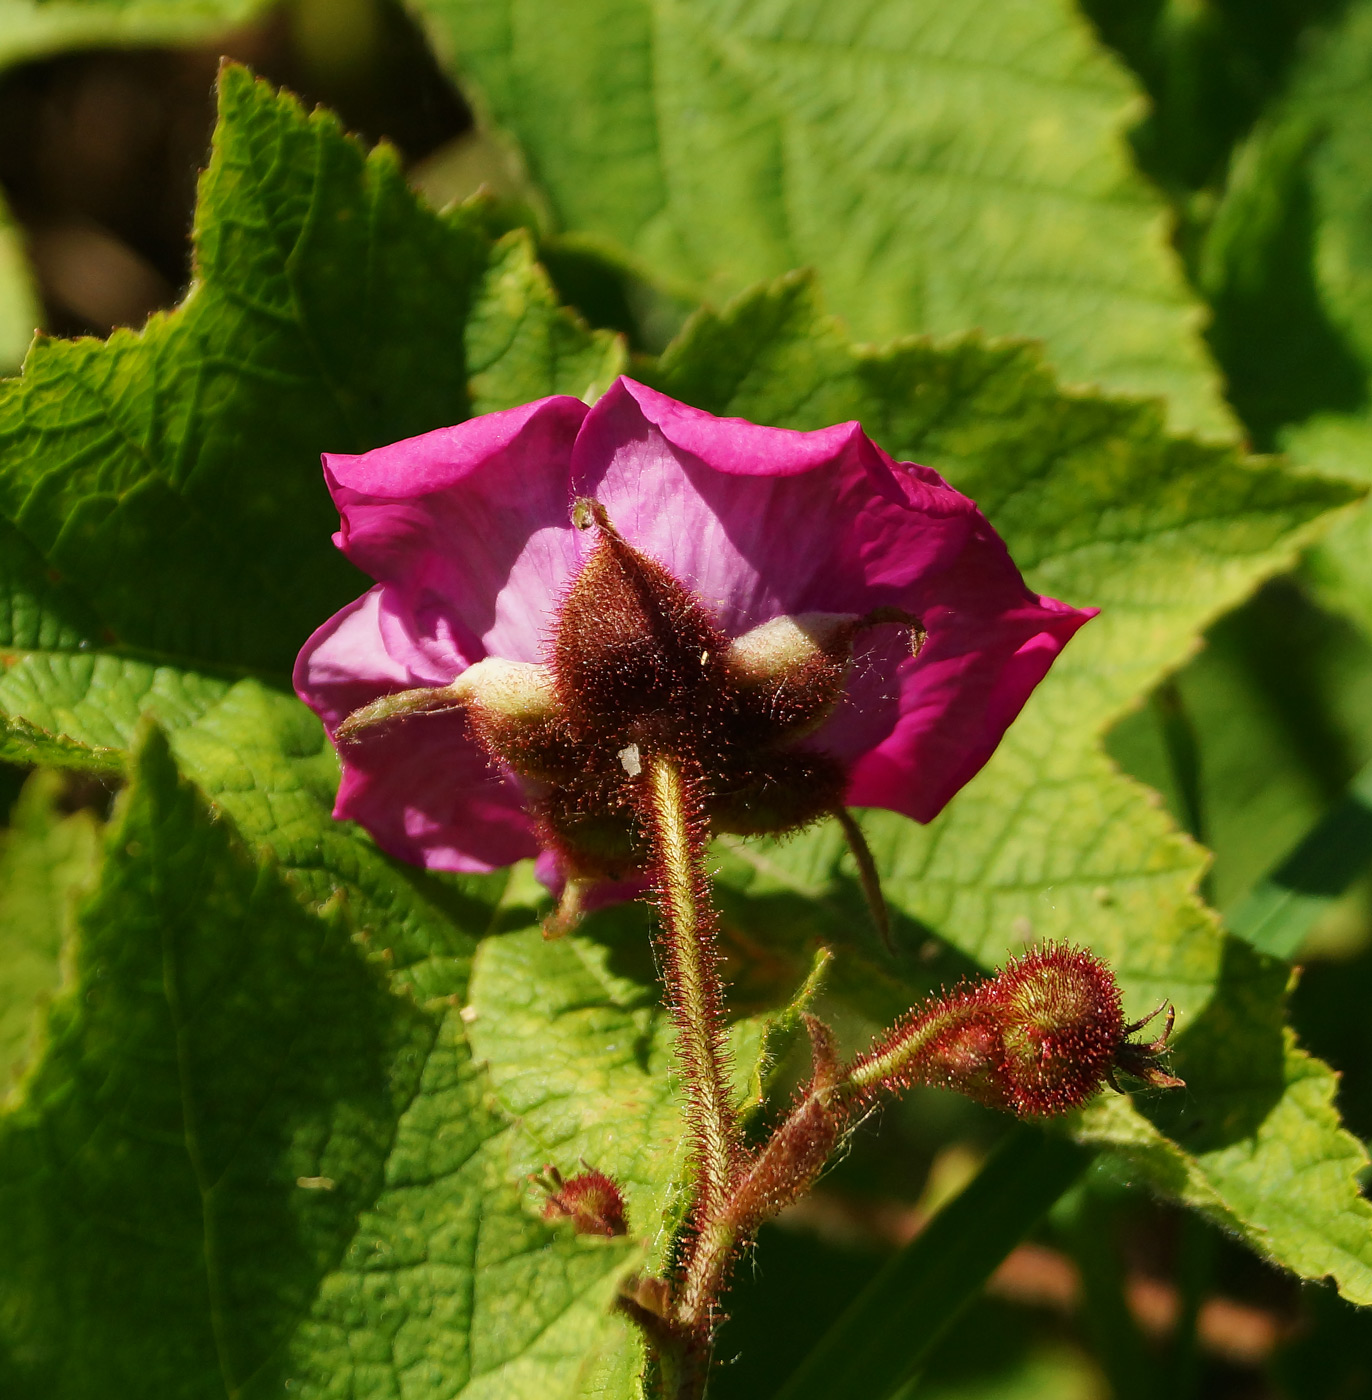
[644,756,739,1336]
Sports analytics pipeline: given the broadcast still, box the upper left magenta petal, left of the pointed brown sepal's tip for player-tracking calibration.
[323,396,587,660]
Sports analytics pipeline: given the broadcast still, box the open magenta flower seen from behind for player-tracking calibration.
[295,379,1093,874]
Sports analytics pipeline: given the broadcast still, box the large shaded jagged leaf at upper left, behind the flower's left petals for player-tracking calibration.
[0,69,620,673]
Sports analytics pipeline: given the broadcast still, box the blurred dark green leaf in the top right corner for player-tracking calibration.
[1200,0,1372,641]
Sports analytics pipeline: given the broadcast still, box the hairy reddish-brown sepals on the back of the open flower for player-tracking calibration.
[337,500,924,879]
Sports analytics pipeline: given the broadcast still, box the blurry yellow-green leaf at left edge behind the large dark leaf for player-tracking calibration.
[0,773,97,1093]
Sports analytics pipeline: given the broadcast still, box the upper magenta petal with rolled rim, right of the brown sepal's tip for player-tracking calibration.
[573,379,976,636]
